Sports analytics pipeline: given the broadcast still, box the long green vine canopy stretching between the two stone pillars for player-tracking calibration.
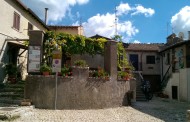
[44,31,107,63]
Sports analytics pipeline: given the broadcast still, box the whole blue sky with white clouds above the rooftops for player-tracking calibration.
[22,0,190,43]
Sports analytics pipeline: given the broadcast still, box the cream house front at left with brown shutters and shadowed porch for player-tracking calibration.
[0,0,48,82]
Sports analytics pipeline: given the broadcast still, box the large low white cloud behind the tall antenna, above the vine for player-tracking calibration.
[81,13,139,38]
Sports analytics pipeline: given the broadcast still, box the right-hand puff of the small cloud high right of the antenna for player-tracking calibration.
[131,5,155,17]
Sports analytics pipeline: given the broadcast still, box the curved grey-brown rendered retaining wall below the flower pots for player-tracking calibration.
[25,68,135,109]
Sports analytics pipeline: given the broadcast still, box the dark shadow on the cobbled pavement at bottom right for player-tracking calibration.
[132,97,190,122]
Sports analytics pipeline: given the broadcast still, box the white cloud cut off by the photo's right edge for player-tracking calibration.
[171,6,190,39]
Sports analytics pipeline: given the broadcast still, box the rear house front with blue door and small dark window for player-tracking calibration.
[124,43,163,92]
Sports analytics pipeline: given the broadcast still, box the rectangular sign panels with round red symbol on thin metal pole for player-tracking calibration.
[52,50,61,72]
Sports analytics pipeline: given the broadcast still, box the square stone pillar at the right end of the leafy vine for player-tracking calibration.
[104,40,117,81]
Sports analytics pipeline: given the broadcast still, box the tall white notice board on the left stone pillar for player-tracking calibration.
[28,46,41,72]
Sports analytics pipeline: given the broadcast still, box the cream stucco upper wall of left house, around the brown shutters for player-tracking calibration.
[0,0,46,42]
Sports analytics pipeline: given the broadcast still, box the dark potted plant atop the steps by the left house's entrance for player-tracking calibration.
[5,63,18,83]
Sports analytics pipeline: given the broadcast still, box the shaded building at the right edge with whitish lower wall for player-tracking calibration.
[160,34,190,101]
